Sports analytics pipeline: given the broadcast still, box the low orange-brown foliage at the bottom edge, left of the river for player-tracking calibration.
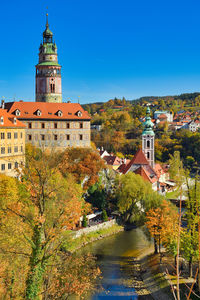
[43,253,101,300]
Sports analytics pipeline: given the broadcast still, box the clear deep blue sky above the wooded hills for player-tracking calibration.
[0,0,200,104]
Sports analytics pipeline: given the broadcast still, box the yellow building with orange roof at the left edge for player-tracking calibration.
[0,108,26,176]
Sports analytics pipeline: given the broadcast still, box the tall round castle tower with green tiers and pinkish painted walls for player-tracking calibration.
[36,14,62,103]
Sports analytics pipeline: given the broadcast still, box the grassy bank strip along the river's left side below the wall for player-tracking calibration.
[63,224,124,252]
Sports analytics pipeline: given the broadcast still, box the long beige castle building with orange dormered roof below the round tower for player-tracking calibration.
[5,101,90,151]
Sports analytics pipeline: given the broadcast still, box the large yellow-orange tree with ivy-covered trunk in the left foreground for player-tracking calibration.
[0,146,89,300]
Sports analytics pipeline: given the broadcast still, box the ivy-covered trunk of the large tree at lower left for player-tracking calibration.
[26,225,45,300]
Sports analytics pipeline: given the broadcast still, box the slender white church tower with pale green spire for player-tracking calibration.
[142,107,155,168]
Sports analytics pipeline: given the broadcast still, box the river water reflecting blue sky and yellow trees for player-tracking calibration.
[81,228,152,300]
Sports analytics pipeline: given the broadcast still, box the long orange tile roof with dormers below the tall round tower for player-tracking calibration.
[5,101,90,120]
